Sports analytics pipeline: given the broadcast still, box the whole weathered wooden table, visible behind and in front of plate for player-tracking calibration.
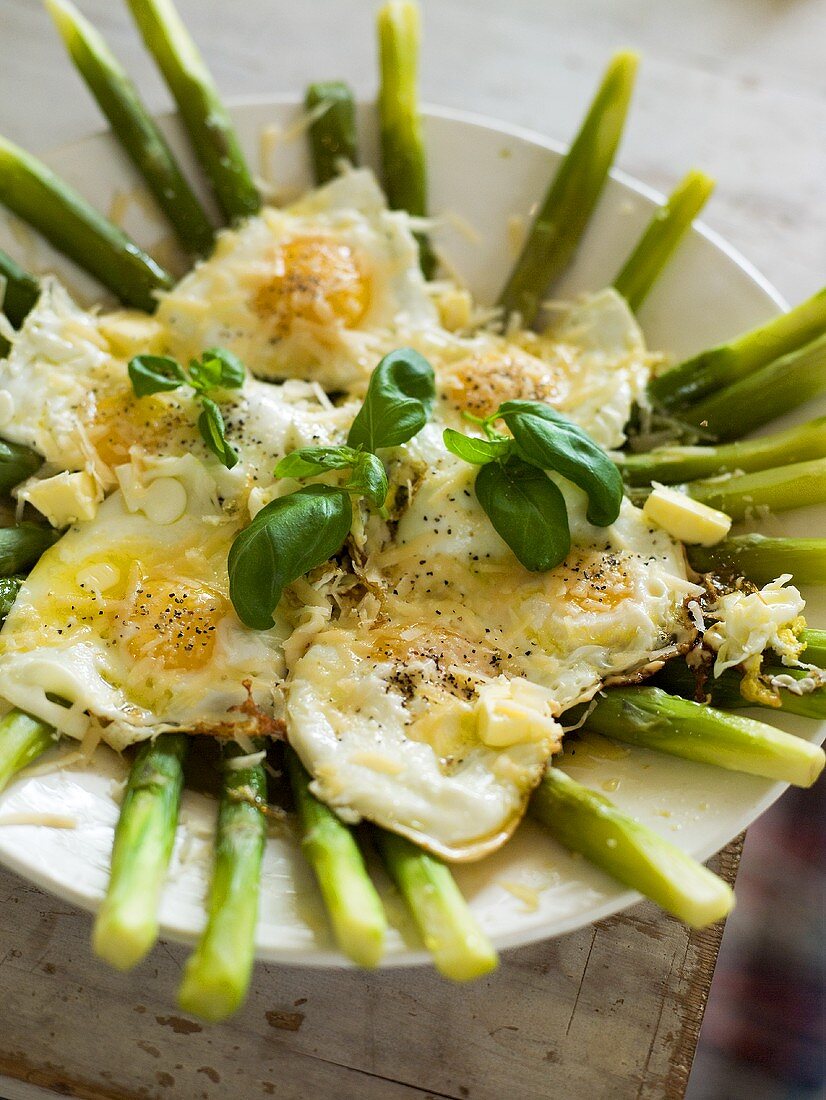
[0,0,826,1100]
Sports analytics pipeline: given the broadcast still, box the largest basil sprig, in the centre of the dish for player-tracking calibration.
[227,348,436,630]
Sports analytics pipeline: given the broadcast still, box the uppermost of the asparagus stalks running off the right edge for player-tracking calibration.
[648,288,826,411]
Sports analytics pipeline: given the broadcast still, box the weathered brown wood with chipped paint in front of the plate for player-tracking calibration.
[0,843,740,1100]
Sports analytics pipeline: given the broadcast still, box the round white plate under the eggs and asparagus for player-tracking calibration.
[0,100,826,966]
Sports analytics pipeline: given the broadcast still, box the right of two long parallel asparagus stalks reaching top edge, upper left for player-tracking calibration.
[128,0,261,221]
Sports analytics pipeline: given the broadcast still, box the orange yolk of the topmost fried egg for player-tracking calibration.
[255,237,370,340]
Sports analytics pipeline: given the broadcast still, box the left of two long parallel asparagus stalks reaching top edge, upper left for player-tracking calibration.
[46,0,212,255]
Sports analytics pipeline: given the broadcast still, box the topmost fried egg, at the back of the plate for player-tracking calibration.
[157,171,438,392]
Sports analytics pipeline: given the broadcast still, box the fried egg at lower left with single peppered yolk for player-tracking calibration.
[0,455,289,748]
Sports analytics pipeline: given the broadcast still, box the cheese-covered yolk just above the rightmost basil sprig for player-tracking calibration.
[448,348,563,417]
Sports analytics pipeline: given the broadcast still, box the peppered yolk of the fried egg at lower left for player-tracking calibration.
[128,578,229,670]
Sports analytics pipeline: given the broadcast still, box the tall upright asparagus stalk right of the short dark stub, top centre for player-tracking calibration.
[376,0,437,278]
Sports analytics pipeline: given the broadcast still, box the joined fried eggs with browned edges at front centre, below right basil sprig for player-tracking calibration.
[287,391,702,860]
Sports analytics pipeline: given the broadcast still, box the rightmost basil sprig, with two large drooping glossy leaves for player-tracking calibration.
[443,402,623,573]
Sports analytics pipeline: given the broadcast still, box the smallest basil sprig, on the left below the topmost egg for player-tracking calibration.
[129,348,244,470]
